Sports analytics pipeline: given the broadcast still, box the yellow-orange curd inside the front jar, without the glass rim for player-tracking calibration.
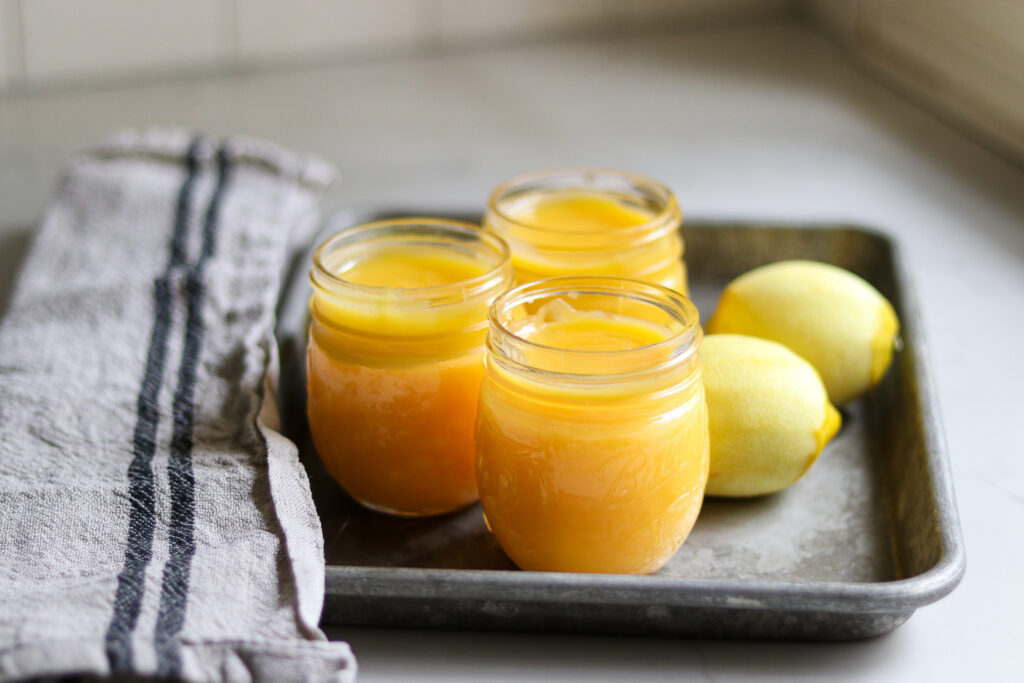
[476,301,709,573]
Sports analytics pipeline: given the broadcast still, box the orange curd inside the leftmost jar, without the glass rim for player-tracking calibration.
[308,246,486,515]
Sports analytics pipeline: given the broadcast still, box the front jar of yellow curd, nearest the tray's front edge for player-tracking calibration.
[476,276,709,573]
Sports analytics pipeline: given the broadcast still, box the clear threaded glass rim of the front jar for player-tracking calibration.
[487,275,703,381]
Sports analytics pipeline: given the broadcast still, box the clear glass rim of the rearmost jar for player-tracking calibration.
[487,166,682,237]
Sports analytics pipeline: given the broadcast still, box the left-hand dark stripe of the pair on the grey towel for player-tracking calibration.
[105,139,200,672]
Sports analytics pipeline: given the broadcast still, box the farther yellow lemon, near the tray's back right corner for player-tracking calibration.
[708,261,899,405]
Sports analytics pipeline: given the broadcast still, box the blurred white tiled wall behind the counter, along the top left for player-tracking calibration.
[0,0,795,92]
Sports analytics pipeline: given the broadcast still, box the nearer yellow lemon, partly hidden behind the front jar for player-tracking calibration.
[700,335,841,497]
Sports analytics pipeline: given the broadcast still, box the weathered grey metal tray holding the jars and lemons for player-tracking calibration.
[279,212,965,639]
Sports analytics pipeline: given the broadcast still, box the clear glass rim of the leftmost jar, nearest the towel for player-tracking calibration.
[309,216,511,301]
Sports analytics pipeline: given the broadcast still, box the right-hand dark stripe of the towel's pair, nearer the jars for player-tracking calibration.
[156,146,230,678]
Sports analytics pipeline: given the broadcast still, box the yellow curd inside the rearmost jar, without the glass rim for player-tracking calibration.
[497,190,686,294]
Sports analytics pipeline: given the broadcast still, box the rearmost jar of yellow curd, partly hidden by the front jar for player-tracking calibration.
[483,168,687,294]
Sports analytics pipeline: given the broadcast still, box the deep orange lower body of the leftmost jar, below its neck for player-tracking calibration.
[306,339,483,517]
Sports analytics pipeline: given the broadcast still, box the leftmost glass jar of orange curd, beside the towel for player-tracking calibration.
[307,218,512,516]
